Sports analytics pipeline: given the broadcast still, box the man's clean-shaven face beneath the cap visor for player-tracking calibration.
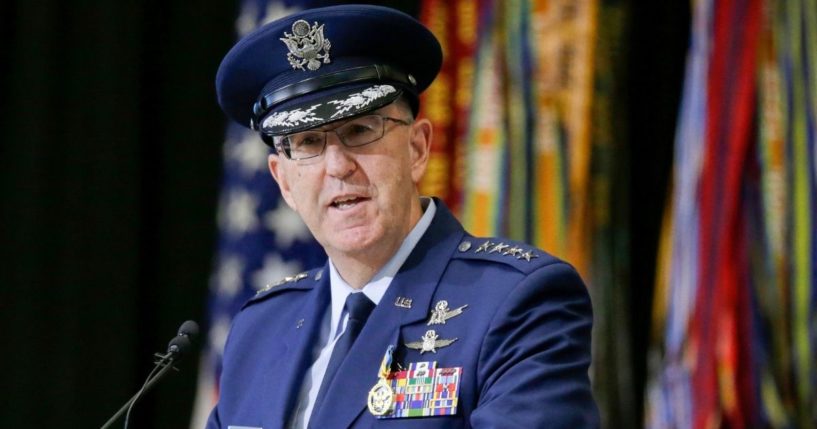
[269,103,431,260]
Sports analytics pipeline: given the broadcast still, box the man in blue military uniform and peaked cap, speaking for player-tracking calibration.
[208,5,598,429]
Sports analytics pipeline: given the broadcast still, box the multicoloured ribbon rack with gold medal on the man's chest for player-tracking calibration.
[370,361,462,419]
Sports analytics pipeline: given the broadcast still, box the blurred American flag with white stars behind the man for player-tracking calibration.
[191,0,326,429]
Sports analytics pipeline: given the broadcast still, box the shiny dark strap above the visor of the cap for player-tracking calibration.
[250,64,417,131]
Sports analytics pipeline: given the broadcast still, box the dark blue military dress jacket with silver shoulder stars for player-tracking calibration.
[207,200,599,429]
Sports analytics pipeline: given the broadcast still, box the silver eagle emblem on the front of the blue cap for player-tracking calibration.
[281,19,332,71]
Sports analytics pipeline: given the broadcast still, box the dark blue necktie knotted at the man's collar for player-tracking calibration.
[312,292,374,417]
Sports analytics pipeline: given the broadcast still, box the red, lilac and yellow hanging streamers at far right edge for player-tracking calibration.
[646,0,817,428]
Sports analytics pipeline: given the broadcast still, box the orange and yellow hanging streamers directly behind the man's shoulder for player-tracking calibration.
[421,0,634,425]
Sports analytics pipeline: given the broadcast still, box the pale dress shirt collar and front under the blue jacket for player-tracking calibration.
[290,197,437,429]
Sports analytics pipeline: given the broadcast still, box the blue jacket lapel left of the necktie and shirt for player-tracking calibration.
[259,267,329,427]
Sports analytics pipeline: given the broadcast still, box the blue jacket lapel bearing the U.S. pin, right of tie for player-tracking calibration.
[309,200,463,428]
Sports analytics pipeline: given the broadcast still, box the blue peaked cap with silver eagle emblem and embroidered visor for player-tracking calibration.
[216,5,442,136]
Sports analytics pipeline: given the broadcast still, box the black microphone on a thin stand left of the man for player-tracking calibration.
[102,320,199,429]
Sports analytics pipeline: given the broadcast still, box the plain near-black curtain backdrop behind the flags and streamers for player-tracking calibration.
[0,0,689,428]
